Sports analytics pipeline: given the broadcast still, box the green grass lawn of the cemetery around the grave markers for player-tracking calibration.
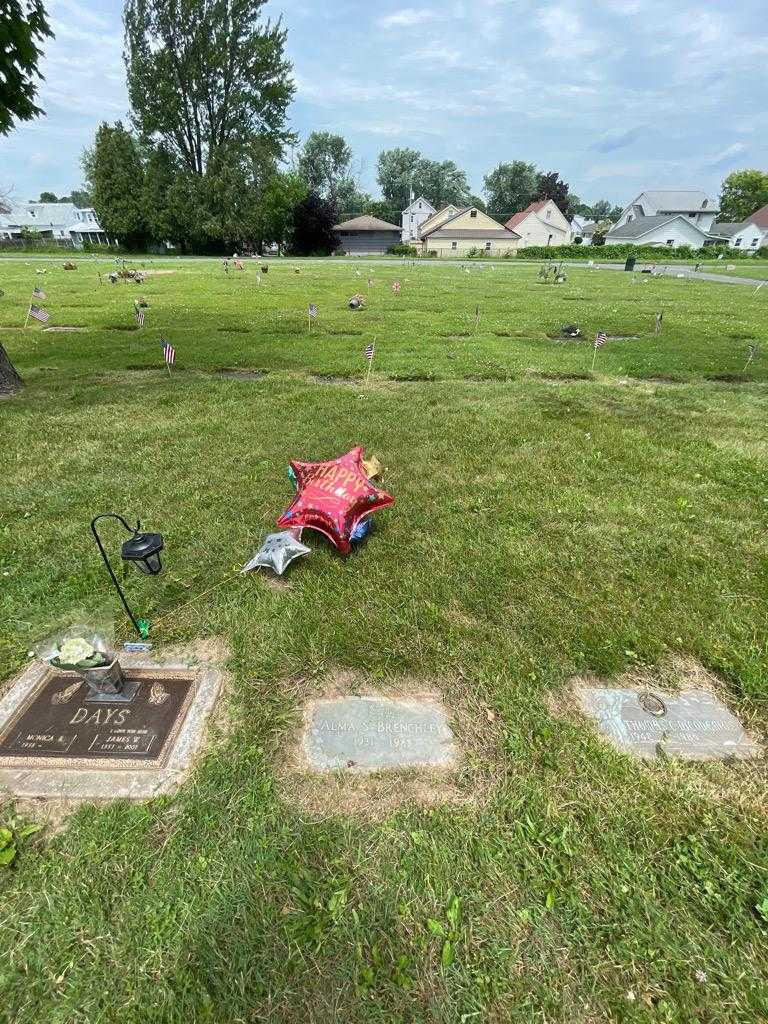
[0,259,768,1024]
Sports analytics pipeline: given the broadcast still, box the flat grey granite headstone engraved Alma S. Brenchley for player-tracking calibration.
[304,697,457,771]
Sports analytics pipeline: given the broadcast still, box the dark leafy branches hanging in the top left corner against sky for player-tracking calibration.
[0,0,53,135]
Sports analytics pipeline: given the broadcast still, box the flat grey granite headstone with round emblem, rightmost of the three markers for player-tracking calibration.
[577,687,762,761]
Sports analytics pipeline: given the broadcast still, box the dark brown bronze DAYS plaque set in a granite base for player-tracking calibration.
[0,673,193,767]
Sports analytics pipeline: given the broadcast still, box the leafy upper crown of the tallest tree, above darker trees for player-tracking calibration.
[123,0,295,175]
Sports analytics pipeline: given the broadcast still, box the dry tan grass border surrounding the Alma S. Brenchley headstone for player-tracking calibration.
[275,671,505,820]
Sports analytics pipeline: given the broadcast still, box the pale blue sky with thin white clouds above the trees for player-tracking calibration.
[0,0,768,205]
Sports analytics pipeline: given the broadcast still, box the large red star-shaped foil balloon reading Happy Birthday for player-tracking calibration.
[278,447,394,555]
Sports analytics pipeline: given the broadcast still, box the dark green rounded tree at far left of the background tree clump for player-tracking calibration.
[83,121,147,249]
